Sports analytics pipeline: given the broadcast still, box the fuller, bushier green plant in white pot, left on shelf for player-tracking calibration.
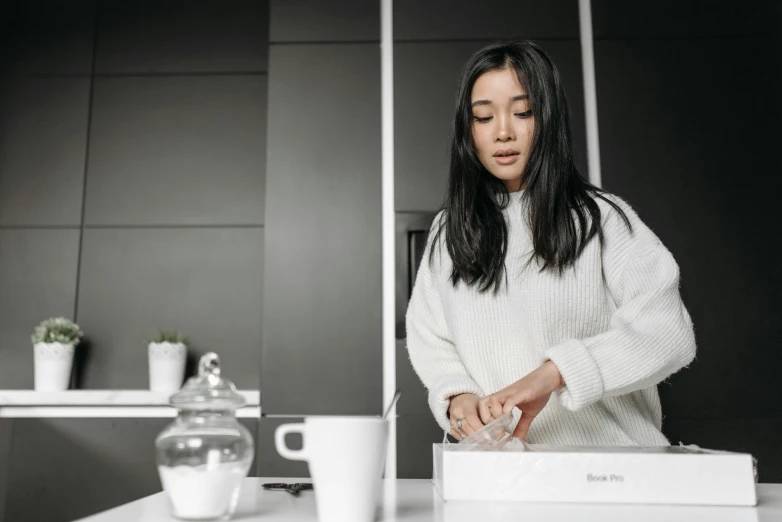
[31,317,84,391]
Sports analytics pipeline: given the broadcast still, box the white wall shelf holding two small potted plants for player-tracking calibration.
[0,390,261,418]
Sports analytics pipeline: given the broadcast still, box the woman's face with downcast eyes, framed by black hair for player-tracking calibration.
[470,68,535,192]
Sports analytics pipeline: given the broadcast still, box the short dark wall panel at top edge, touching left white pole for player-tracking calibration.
[269,0,380,42]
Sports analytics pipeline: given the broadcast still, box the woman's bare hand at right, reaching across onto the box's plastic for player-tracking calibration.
[478,361,564,440]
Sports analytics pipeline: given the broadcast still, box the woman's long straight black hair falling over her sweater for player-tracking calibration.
[429,42,632,293]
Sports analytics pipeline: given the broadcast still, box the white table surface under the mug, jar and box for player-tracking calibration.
[75,478,782,522]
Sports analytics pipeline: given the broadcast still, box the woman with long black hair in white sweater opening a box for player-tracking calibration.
[406,42,695,446]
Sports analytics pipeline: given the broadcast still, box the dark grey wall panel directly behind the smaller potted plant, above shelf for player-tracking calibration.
[78,228,263,389]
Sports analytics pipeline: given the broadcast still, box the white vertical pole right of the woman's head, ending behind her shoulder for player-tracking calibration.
[578,0,603,187]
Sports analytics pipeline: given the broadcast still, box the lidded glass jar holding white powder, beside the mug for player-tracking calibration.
[155,352,255,520]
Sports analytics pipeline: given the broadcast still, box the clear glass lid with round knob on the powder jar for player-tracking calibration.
[169,352,246,410]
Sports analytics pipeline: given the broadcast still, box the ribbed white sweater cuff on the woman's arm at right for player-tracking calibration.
[545,339,603,411]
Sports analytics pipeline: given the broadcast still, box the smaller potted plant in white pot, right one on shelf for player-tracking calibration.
[149,332,187,392]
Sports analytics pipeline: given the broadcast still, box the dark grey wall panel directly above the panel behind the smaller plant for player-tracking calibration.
[85,76,266,225]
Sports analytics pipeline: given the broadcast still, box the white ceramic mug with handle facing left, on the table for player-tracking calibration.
[274,416,388,522]
